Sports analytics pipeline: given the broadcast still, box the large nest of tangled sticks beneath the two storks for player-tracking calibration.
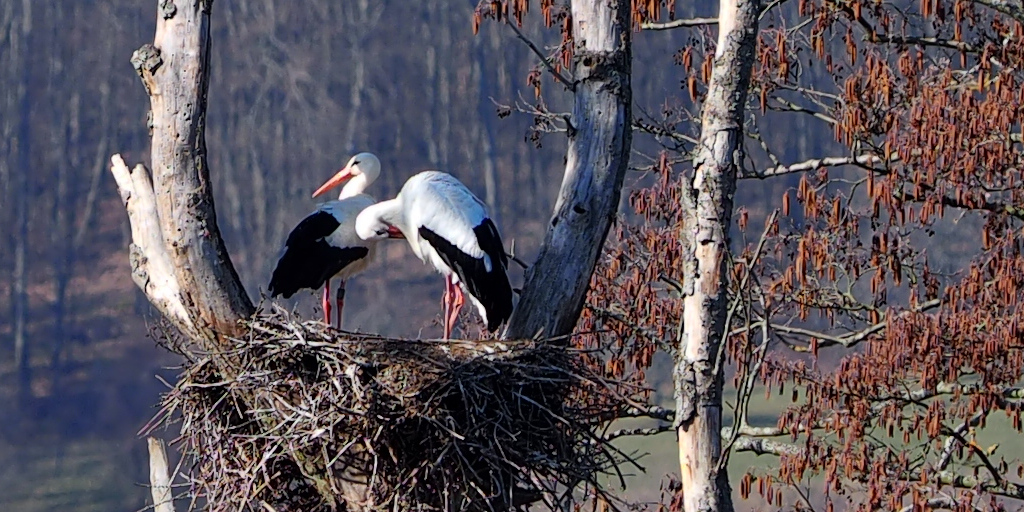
[150,311,631,511]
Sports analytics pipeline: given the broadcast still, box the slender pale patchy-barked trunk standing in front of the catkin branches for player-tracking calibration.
[674,0,760,512]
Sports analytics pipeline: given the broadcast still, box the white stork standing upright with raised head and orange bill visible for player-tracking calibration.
[269,153,381,327]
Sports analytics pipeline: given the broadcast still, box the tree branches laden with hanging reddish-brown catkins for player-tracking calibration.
[585,0,1024,511]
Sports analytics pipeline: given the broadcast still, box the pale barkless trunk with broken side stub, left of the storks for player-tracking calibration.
[112,0,254,340]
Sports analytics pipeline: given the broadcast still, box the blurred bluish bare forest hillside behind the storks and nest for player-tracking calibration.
[0,0,937,512]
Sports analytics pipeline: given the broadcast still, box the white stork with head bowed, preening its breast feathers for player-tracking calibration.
[355,171,512,339]
